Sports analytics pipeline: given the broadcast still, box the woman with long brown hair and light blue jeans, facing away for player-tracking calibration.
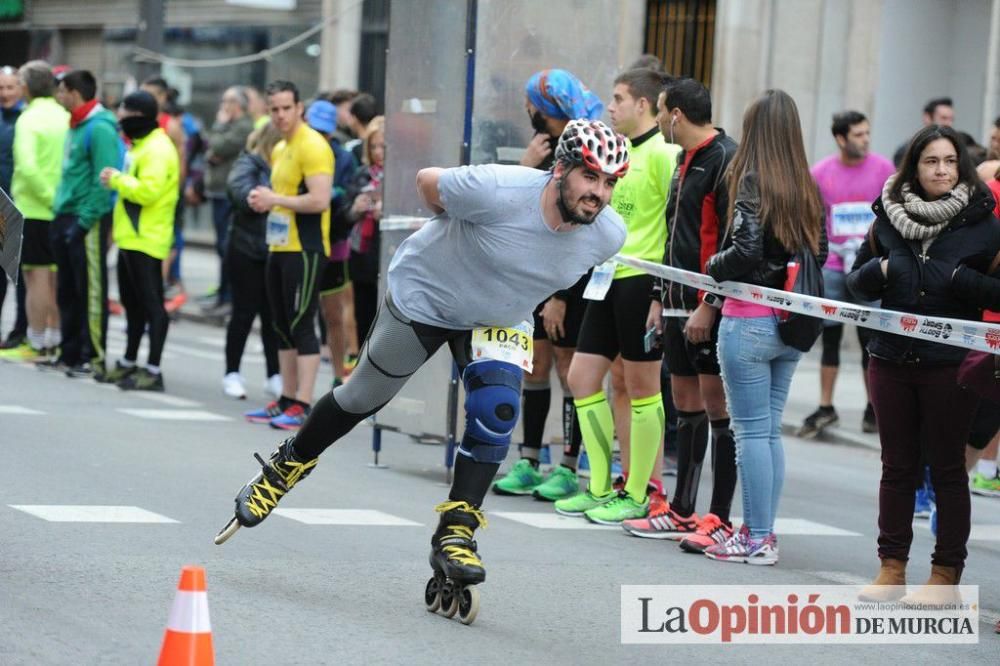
[705,90,826,564]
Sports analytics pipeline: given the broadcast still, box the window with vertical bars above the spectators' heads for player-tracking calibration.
[645,0,716,88]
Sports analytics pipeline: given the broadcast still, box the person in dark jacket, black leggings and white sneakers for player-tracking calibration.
[222,123,281,399]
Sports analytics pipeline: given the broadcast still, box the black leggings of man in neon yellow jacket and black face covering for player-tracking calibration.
[118,250,170,367]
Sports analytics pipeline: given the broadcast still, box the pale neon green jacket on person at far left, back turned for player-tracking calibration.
[10,97,69,221]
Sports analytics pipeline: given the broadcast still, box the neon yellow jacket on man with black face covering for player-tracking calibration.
[108,128,180,259]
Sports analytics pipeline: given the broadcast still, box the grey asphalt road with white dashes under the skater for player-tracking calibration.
[0,308,1000,666]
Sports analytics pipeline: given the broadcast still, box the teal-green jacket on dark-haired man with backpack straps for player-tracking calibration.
[54,104,124,229]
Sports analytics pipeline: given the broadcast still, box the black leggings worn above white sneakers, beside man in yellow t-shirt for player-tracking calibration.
[226,247,279,377]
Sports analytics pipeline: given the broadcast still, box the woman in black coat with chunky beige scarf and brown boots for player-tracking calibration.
[847,125,1000,603]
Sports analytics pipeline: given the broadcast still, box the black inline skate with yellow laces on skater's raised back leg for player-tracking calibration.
[215,437,319,545]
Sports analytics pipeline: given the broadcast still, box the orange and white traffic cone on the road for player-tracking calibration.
[157,566,215,666]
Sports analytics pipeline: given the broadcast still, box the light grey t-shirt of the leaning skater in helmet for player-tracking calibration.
[388,164,625,329]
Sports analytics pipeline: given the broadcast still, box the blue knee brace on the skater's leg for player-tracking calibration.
[459,360,524,464]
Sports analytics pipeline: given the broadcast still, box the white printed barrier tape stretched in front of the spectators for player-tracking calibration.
[614,254,1000,354]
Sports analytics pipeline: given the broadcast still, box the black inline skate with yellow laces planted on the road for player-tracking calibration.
[424,502,486,624]
